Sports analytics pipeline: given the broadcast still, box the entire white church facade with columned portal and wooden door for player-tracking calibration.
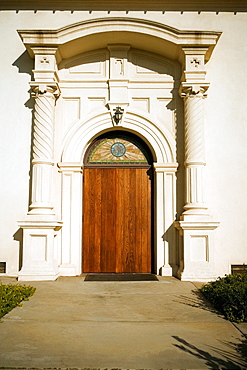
[0,1,247,281]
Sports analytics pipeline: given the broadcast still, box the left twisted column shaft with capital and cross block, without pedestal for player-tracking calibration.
[29,47,60,216]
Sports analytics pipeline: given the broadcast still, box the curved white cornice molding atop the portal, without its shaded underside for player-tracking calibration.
[18,17,221,59]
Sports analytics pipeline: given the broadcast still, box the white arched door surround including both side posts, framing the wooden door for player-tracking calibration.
[58,109,178,276]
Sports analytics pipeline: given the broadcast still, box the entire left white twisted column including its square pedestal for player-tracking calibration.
[18,47,62,281]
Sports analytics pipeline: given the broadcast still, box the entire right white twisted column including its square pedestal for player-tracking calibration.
[175,47,219,281]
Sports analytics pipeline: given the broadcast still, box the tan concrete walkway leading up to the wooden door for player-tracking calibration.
[0,277,247,369]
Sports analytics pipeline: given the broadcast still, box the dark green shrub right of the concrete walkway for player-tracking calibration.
[200,273,247,323]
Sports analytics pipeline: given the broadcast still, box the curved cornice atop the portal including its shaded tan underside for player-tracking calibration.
[18,17,221,63]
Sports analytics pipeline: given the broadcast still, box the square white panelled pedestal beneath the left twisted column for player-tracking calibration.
[18,219,62,281]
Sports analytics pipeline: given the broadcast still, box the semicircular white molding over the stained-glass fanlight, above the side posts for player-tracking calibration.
[61,110,176,164]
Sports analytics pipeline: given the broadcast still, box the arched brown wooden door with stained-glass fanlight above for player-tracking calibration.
[82,131,153,273]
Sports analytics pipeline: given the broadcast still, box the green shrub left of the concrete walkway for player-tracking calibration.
[0,283,36,318]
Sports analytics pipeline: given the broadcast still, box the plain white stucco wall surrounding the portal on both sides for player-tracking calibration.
[0,11,247,275]
